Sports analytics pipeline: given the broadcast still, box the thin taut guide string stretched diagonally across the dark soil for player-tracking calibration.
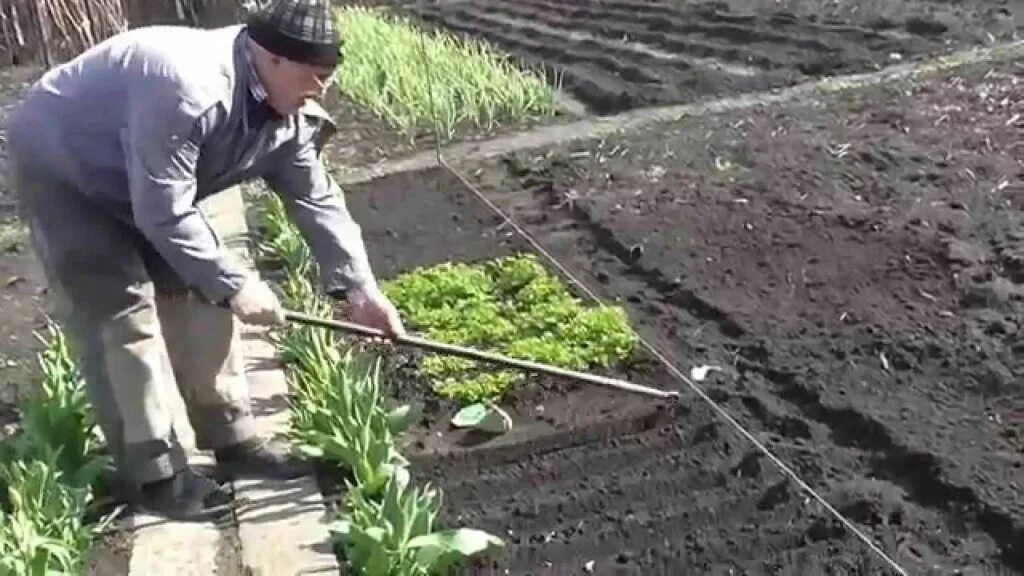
[417,5,907,576]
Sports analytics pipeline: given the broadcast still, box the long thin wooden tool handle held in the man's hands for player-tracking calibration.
[285,311,679,398]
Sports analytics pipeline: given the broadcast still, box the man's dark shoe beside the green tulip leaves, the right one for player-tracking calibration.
[214,437,313,480]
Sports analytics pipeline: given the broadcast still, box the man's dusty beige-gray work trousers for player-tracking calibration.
[12,165,254,486]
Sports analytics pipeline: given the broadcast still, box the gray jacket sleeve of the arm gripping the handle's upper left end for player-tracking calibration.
[122,90,246,302]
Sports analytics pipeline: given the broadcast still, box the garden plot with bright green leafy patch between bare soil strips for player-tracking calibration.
[337,169,675,458]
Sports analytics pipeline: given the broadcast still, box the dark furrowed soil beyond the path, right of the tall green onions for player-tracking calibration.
[403,0,1024,114]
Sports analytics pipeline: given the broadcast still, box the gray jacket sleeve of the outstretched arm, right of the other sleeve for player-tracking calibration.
[264,107,376,297]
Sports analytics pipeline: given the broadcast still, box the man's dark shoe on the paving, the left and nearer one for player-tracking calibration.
[137,468,232,522]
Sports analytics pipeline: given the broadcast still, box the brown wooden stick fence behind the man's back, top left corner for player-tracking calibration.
[0,0,247,67]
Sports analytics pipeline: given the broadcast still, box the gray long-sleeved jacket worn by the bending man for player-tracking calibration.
[8,26,373,301]
